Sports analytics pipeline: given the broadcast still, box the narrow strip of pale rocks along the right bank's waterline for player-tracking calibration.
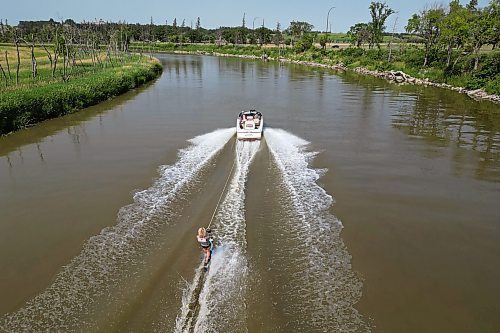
[174,51,500,104]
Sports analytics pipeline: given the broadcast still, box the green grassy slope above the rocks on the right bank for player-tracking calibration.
[135,43,500,95]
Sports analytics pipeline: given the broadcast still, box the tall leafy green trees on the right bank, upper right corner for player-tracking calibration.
[348,0,500,70]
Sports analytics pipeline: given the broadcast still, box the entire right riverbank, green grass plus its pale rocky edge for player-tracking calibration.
[134,43,500,104]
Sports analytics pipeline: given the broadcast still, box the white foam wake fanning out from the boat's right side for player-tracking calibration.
[265,128,369,332]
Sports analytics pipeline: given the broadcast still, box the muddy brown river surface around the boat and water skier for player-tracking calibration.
[0,56,500,332]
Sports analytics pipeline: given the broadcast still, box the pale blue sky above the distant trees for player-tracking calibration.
[0,0,489,32]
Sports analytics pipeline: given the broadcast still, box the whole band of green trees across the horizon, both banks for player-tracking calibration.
[0,0,500,82]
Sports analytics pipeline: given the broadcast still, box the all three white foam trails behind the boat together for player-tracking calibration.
[0,128,369,332]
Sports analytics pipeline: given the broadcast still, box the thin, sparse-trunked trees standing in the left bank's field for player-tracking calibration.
[0,19,152,86]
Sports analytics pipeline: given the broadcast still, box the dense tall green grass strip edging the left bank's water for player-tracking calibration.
[0,56,162,135]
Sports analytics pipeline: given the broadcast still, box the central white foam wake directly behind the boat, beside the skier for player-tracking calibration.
[176,142,260,332]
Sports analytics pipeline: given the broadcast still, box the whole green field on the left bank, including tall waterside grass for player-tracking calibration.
[0,45,162,135]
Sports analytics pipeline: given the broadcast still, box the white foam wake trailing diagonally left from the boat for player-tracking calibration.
[0,128,234,333]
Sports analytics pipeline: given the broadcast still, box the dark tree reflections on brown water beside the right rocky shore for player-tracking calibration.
[336,69,500,182]
